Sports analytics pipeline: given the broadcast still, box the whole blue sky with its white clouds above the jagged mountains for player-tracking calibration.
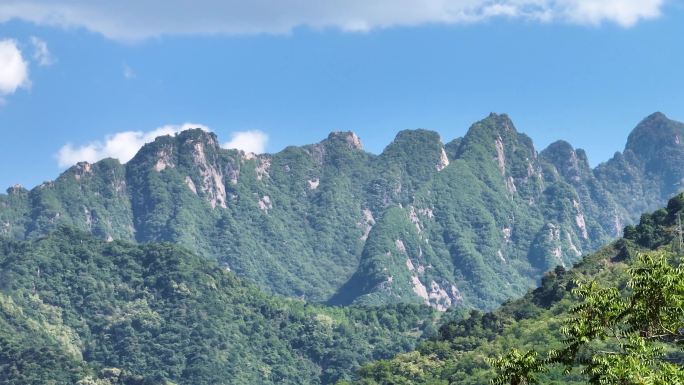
[0,0,684,188]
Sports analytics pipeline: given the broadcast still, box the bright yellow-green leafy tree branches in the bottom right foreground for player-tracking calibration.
[489,252,684,385]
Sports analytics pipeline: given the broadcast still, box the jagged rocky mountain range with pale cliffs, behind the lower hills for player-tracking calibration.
[0,113,684,310]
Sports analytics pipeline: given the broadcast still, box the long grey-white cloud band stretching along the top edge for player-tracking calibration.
[0,0,666,40]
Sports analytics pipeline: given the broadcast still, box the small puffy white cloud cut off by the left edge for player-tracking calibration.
[0,39,31,97]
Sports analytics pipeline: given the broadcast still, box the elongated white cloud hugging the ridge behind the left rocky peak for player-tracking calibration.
[55,123,210,168]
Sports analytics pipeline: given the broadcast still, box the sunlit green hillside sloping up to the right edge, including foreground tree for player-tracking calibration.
[340,194,684,385]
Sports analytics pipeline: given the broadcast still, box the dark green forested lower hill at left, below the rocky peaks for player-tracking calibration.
[0,228,434,385]
